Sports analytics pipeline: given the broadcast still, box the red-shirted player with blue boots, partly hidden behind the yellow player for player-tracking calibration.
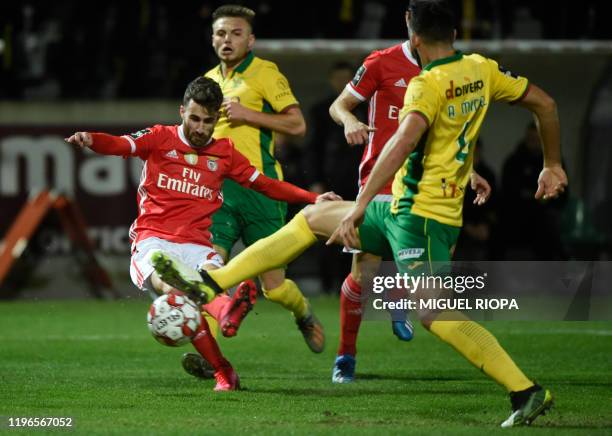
[329,41,490,383]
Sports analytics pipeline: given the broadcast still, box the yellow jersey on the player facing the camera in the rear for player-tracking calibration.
[205,52,298,180]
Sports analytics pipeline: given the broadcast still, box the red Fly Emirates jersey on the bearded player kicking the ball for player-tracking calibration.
[123,125,260,247]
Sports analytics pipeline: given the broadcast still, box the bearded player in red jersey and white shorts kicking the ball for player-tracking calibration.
[66,77,339,390]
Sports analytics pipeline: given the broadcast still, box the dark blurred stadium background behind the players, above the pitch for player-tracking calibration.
[0,0,612,299]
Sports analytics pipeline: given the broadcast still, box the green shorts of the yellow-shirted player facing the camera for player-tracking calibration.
[210,180,287,254]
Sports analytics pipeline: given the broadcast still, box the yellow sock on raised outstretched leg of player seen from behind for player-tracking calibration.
[208,212,317,289]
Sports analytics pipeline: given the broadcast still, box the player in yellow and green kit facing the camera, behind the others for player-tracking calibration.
[205,5,325,353]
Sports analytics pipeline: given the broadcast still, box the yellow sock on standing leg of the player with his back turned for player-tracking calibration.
[430,312,533,392]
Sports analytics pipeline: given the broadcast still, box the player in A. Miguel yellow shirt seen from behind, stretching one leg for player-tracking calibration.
[156,0,567,427]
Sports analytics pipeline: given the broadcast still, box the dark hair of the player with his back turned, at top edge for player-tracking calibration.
[407,0,455,43]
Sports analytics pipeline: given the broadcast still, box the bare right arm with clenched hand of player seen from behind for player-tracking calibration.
[517,84,567,200]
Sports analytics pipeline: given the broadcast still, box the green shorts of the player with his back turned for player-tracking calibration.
[359,202,461,273]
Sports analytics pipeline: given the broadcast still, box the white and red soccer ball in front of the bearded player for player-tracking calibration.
[147,291,202,347]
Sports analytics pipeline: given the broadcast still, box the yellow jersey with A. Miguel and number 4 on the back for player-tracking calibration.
[391,52,529,227]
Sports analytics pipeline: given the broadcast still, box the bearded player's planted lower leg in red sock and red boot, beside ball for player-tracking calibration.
[191,319,240,391]
